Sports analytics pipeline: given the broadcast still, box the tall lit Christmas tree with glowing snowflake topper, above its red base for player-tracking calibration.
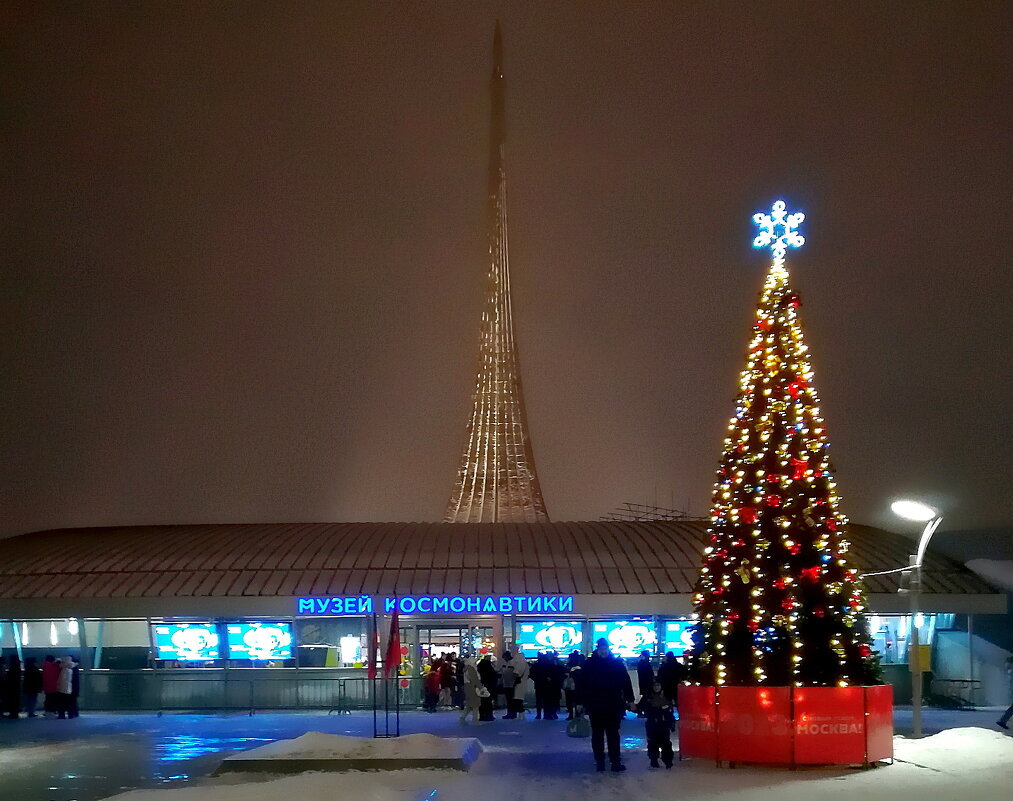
[691,201,877,687]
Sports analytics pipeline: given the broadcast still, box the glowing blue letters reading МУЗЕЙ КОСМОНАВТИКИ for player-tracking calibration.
[296,595,573,617]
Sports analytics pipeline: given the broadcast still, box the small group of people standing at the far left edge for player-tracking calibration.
[0,654,81,720]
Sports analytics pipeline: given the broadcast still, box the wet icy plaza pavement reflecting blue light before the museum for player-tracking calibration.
[0,707,1000,801]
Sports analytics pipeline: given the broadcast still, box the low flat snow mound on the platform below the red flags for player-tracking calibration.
[233,731,465,759]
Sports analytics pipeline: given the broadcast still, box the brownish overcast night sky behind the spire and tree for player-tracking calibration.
[0,0,1013,535]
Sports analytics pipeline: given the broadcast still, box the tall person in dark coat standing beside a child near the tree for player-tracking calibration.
[577,637,634,773]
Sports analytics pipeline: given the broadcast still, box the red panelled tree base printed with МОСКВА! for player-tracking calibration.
[679,685,893,767]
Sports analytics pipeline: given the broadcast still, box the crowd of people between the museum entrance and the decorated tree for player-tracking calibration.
[422,639,687,772]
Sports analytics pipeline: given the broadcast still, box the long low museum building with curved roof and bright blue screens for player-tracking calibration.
[0,519,1006,709]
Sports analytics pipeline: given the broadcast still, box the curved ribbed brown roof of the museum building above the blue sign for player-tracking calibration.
[0,520,1005,615]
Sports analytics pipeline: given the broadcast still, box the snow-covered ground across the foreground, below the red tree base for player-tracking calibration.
[104,727,1013,801]
